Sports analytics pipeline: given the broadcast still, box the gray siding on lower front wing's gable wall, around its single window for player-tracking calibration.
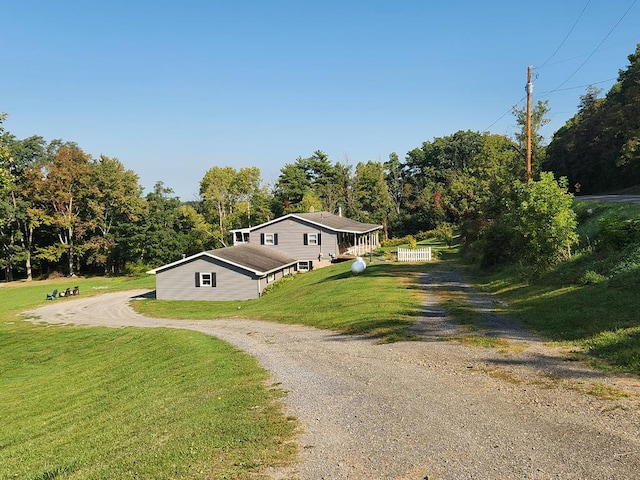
[156,257,266,300]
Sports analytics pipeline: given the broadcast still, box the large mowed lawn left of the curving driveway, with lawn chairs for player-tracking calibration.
[0,278,297,480]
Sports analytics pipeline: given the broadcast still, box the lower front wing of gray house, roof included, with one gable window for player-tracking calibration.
[147,244,298,300]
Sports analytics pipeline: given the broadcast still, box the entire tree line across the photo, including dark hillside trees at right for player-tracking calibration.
[0,46,640,280]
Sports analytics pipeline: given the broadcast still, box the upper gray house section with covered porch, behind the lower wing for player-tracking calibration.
[232,212,382,270]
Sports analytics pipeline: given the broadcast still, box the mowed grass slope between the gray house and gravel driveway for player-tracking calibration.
[133,261,430,342]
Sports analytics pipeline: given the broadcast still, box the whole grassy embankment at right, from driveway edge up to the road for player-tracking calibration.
[450,201,640,375]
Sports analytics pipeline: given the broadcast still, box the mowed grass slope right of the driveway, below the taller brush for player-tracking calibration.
[464,258,640,375]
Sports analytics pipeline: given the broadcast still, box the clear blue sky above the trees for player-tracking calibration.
[0,0,640,200]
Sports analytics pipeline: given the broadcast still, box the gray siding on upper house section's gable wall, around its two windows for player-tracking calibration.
[249,218,338,261]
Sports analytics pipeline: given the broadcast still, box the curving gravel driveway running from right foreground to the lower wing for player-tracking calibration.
[23,269,640,480]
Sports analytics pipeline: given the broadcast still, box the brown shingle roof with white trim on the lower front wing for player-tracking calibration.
[147,243,298,275]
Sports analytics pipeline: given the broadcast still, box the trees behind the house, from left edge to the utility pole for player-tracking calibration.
[0,113,568,280]
